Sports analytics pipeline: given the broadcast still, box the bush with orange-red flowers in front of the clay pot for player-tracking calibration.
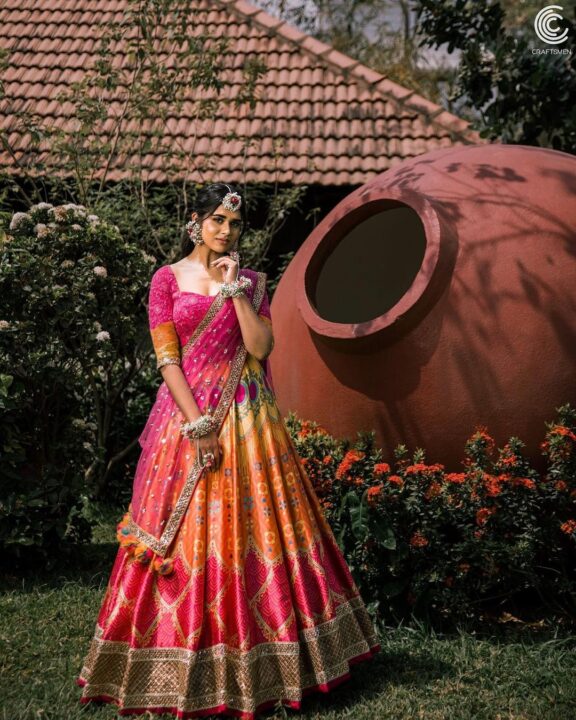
[287,405,576,632]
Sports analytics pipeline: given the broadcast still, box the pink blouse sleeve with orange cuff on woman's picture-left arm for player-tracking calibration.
[148,267,180,369]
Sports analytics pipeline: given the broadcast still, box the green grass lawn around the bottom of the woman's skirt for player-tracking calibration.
[0,510,576,720]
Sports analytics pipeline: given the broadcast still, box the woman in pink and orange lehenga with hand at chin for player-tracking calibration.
[77,184,379,718]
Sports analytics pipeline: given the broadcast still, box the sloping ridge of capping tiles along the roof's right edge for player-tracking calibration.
[216,0,477,140]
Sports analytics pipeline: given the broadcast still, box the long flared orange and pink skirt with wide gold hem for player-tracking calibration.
[76,355,380,718]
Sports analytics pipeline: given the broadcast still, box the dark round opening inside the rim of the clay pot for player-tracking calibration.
[309,203,426,323]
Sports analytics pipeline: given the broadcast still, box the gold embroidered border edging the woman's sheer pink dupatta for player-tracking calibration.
[127,273,266,557]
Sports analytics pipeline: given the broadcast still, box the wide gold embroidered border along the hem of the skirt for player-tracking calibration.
[80,596,378,712]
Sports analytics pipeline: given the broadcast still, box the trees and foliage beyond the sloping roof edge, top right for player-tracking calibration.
[259,0,576,153]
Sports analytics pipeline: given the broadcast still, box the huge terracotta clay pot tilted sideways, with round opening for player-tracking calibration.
[270,145,576,470]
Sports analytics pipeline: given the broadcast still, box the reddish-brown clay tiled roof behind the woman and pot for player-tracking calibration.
[0,0,482,185]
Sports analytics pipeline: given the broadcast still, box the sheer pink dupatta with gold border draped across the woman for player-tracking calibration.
[127,270,272,557]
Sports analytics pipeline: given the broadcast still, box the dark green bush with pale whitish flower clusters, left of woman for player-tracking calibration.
[0,203,155,560]
